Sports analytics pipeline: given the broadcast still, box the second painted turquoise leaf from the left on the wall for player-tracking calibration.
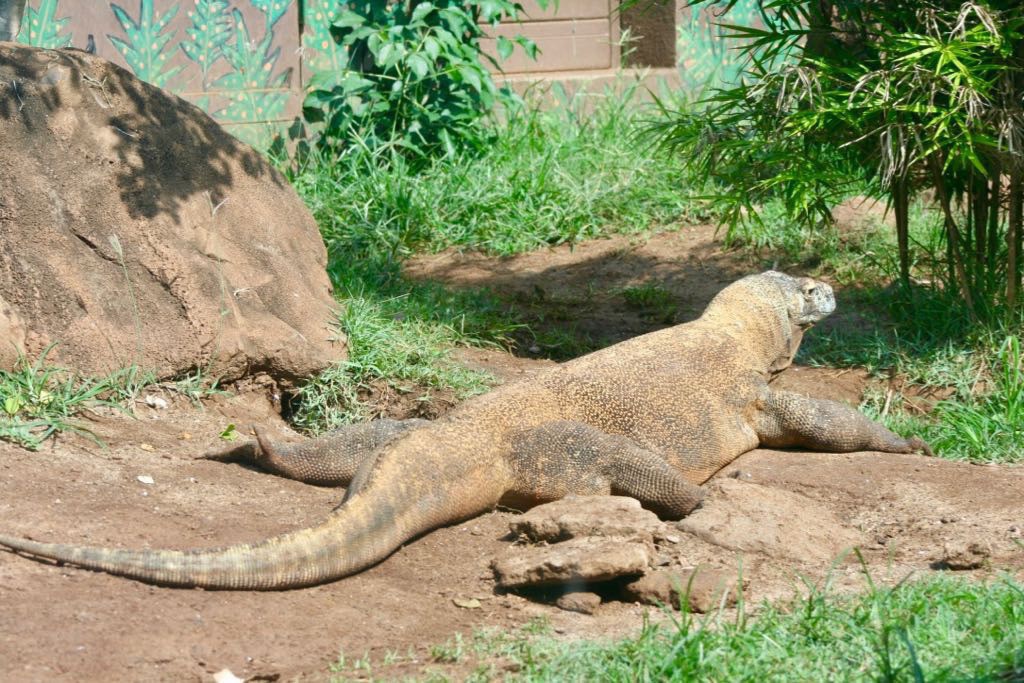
[106,0,184,88]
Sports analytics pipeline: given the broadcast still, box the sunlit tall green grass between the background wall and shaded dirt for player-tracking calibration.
[290,83,695,257]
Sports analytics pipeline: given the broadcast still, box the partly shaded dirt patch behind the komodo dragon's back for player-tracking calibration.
[404,225,764,360]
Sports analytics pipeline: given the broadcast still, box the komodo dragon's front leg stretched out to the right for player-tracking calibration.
[753,390,932,456]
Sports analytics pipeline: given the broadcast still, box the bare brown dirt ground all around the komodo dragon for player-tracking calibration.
[0,228,1024,681]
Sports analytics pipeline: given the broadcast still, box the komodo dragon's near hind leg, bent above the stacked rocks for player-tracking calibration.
[512,421,703,519]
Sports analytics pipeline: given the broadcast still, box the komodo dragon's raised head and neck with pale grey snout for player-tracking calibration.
[703,270,836,373]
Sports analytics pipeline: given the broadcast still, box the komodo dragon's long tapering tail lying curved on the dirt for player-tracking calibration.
[0,438,502,591]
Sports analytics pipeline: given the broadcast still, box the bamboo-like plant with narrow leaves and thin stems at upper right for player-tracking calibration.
[656,0,1024,321]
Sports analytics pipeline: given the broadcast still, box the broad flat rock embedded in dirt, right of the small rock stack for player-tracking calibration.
[677,478,864,564]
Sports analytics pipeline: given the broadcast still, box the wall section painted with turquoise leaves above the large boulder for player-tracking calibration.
[17,0,321,145]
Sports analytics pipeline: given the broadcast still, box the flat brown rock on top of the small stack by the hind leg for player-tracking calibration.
[509,496,671,543]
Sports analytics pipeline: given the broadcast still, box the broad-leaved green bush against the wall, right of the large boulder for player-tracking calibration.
[304,0,547,156]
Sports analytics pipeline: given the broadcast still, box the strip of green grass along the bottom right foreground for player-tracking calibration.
[332,575,1024,682]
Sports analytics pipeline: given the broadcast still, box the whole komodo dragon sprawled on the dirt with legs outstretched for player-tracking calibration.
[0,271,929,590]
